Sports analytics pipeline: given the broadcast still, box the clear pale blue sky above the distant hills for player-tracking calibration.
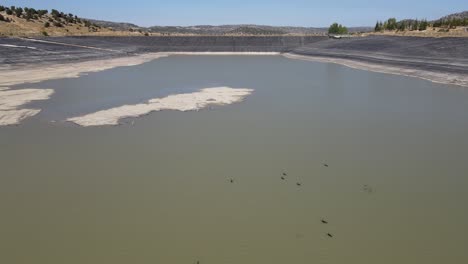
[0,0,468,27]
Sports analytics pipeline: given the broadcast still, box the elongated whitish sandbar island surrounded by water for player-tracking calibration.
[67,87,253,126]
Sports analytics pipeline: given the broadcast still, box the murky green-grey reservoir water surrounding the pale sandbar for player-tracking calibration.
[0,56,468,264]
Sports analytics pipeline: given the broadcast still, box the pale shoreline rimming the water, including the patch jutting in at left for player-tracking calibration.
[0,52,468,126]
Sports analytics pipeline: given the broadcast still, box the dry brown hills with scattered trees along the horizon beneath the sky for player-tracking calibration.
[0,6,468,37]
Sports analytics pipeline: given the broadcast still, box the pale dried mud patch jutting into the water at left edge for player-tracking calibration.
[0,89,54,126]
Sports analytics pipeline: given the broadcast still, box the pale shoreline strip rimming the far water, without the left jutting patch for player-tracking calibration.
[0,52,468,88]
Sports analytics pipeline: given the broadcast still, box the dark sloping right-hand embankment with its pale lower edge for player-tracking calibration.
[288,36,468,87]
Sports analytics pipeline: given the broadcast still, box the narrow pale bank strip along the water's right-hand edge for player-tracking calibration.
[282,53,468,87]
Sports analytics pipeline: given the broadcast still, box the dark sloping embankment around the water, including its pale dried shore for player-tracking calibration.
[0,36,468,125]
